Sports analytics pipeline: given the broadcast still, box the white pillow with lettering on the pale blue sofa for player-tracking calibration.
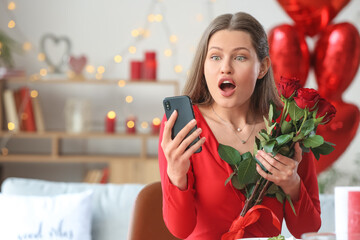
[0,191,92,240]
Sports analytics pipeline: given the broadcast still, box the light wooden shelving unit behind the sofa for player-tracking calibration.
[0,77,176,183]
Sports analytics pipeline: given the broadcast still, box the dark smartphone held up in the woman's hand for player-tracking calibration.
[163,96,201,153]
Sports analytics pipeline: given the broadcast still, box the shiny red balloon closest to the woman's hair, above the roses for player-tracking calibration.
[268,24,310,86]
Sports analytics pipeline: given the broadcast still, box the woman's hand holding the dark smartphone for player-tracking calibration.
[161,110,205,190]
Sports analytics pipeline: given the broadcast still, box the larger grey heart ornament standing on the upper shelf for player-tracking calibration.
[40,34,71,73]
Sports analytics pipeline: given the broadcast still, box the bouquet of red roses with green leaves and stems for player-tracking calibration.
[218,77,336,239]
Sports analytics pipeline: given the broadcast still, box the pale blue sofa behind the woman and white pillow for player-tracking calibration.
[0,178,335,240]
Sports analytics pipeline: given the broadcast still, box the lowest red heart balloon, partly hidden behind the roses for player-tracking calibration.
[315,101,360,174]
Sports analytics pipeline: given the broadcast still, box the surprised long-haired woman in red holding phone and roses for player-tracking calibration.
[159,12,321,240]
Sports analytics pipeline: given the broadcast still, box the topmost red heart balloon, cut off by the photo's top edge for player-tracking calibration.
[277,0,350,36]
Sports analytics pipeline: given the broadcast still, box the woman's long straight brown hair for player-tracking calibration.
[183,12,282,115]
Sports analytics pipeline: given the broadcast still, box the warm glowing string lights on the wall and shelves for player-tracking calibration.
[0,0,216,154]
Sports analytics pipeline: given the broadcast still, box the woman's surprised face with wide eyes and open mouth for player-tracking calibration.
[204,30,261,108]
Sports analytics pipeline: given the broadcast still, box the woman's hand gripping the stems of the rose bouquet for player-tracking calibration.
[256,143,302,201]
